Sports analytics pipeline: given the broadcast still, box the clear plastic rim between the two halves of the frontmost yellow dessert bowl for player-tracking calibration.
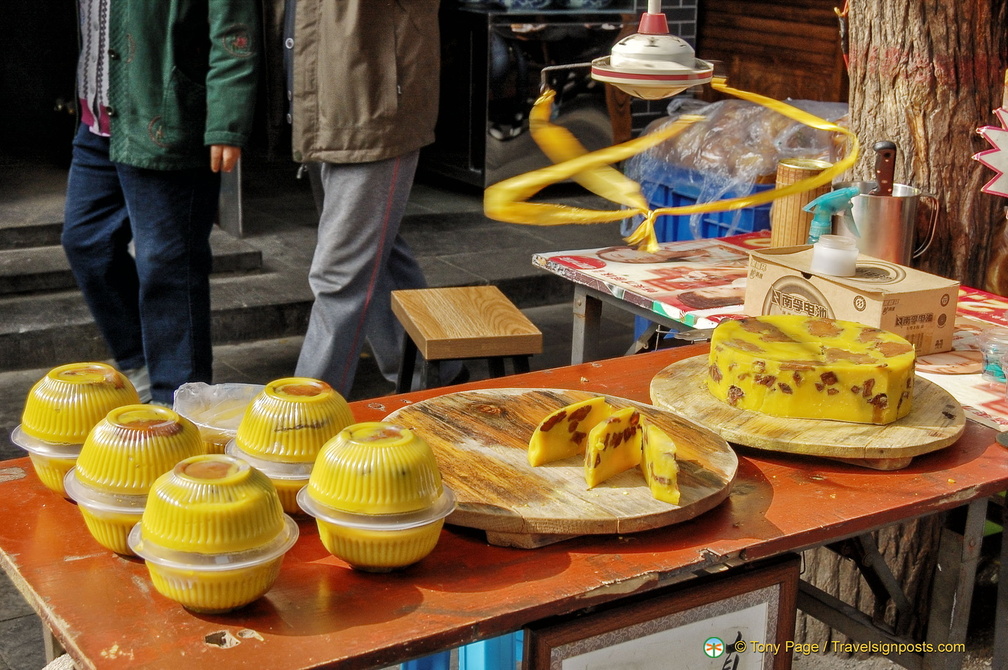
[126,514,299,572]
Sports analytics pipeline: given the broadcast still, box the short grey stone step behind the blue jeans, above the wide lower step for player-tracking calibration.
[0,226,262,295]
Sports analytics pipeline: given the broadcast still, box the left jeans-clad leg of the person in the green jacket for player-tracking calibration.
[61,126,145,370]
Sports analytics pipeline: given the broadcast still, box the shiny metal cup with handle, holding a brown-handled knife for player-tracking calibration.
[833,181,938,265]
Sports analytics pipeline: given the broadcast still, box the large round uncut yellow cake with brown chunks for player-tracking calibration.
[707,314,916,424]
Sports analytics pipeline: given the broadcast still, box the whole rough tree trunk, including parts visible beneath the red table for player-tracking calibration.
[795,0,1008,644]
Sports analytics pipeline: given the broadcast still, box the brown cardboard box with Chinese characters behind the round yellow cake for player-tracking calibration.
[744,245,959,356]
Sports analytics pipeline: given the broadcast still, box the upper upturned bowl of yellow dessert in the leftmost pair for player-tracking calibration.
[21,363,140,444]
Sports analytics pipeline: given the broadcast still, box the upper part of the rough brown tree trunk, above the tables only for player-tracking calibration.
[849,0,1008,288]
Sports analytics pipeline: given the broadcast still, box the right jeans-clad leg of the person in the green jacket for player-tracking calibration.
[117,164,220,405]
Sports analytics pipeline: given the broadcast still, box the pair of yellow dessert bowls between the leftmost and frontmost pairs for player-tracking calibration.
[64,405,206,555]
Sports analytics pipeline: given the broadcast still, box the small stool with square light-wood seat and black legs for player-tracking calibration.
[392,286,542,393]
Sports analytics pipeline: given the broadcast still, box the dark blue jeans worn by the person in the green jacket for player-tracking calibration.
[62,126,220,405]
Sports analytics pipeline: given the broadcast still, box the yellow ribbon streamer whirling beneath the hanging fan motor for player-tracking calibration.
[483,73,859,252]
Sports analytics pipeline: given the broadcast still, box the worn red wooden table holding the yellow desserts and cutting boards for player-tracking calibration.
[0,346,1008,669]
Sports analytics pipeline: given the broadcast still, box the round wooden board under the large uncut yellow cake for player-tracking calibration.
[651,355,966,470]
